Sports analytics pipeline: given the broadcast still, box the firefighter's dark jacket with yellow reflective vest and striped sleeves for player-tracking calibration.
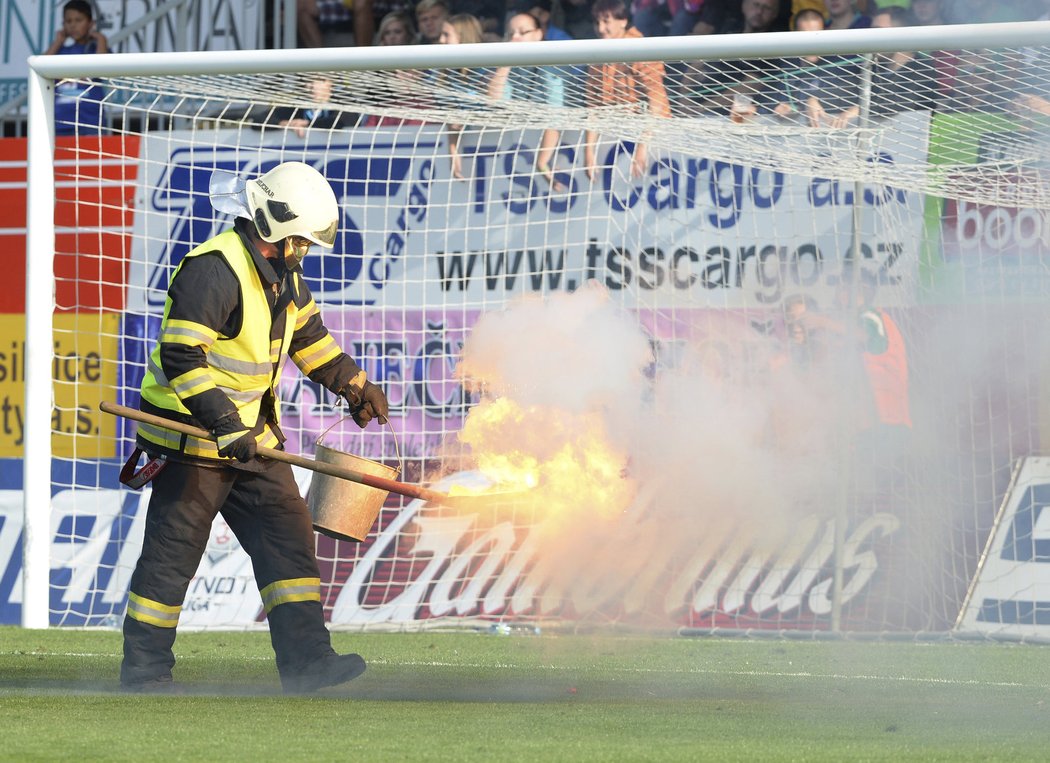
[139,219,365,468]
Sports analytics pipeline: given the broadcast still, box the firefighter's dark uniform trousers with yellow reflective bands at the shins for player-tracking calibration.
[121,459,334,684]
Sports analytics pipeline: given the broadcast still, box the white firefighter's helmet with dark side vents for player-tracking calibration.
[246,162,339,249]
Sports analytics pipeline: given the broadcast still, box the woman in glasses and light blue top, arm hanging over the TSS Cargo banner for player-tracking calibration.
[488,14,565,191]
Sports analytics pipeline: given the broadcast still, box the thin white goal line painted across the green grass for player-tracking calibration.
[0,651,1043,688]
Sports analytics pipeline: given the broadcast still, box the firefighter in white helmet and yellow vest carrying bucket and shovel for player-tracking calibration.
[121,162,389,693]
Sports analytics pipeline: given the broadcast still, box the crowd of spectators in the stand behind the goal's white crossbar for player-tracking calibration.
[297,0,1050,128]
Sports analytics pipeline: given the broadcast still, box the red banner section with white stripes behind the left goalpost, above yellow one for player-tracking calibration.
[0,135,140,314]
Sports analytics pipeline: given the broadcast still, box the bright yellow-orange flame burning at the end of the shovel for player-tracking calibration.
[460,397,634,518]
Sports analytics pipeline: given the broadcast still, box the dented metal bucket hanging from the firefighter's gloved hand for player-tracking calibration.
[307,424,401,541]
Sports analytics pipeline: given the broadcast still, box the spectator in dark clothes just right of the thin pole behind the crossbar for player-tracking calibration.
[870,5,941,116]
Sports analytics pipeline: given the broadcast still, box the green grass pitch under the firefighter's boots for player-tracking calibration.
[0,628,1050,763]
